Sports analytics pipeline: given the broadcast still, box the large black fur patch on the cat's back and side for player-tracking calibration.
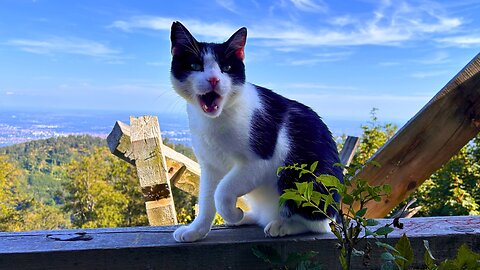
[250,86,343,220]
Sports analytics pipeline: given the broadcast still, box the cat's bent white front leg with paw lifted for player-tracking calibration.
[215,162,263,224]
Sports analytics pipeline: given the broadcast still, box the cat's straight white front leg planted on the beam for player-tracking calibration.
[173,166,222,242]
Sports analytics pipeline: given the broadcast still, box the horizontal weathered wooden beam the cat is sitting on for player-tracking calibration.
[0,216,480,270]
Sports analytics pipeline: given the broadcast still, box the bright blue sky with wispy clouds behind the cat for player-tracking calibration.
[0,0,480,122]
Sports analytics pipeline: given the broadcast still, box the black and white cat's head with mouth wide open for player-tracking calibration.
[171,22,247,118]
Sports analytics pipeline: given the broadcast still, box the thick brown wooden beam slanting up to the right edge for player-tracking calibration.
[355,54,480,217]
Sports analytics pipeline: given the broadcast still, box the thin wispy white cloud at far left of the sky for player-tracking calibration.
[6,37,120,57]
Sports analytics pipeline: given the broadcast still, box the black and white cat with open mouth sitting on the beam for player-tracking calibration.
[171,22,343,242]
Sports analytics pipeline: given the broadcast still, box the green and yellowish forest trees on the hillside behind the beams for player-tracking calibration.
[0,111,480,231]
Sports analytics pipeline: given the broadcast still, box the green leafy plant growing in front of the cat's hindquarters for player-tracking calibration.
[277,162,404,269]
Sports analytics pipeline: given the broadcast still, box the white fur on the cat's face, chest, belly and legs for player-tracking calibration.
[172,51,329,242]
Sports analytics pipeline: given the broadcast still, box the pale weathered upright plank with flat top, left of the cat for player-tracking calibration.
[130,116,177,226]
